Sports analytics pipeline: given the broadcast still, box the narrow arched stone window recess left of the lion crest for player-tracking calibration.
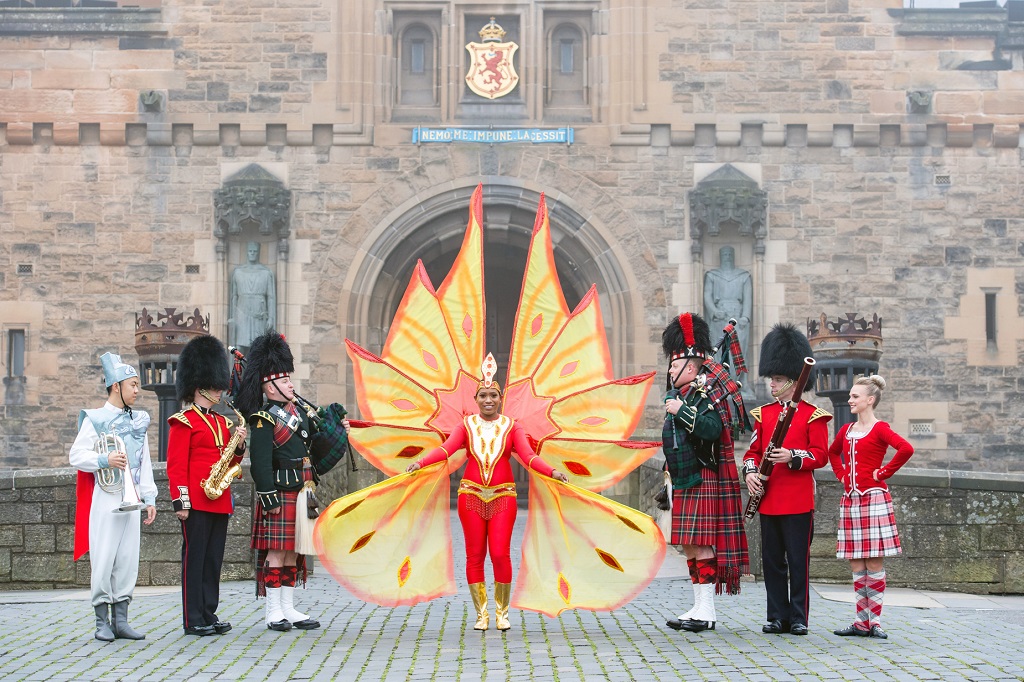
[392,12,441,122]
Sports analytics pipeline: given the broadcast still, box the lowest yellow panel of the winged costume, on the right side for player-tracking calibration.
[512,474,665,617]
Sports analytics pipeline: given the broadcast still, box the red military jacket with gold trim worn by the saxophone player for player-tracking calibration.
[167,404,245,514]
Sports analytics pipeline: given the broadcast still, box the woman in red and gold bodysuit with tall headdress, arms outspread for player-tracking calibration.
[408,353,568,630]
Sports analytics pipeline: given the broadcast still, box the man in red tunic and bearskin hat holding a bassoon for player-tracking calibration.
[743,325,831,635]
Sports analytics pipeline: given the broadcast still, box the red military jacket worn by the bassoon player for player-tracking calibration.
[743,400,831,509]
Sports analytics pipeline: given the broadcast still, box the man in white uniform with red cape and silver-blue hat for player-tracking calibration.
[71,353,157,642]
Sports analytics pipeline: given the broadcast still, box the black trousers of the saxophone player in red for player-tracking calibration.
[181,509,231,628]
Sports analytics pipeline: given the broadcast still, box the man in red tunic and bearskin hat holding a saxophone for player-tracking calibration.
[167,336,246,636]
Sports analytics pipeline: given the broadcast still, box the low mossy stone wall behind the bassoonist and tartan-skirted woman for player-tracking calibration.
[748,468,1024,594]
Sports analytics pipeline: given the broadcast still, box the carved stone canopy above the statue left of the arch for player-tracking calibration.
[213,164,292,258]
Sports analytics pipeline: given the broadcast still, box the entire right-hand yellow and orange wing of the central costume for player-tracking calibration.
[503,191,665,616]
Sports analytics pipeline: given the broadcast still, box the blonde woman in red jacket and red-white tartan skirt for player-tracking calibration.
[828,375,913,639]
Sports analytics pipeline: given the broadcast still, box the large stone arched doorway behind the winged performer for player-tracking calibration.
[342,184,636,494]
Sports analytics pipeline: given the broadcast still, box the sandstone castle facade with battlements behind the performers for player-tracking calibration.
[0,0,1024,481]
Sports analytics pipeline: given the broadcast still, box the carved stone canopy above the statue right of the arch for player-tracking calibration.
[690,164,768,256]
